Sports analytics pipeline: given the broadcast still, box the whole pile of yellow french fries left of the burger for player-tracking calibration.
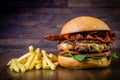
[7,46,58,73]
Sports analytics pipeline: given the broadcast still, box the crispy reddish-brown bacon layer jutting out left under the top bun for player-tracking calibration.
[44,31,115,43]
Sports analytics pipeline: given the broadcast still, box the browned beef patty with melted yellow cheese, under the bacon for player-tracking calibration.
[57,40,112,53]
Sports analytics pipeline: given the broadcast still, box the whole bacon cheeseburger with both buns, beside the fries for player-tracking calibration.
[44,16,118,69]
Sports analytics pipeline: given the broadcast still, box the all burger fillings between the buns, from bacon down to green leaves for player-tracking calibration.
[44,31,117,61]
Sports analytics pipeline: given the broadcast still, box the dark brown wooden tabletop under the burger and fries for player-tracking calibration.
[0,53,120,80]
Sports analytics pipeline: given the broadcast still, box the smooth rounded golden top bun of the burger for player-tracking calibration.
[60,16,110,35]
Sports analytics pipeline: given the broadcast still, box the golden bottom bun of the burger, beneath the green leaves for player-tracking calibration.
[58,55,111,69]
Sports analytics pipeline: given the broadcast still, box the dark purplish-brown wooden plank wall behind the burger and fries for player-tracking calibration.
[0,0,120,80]
